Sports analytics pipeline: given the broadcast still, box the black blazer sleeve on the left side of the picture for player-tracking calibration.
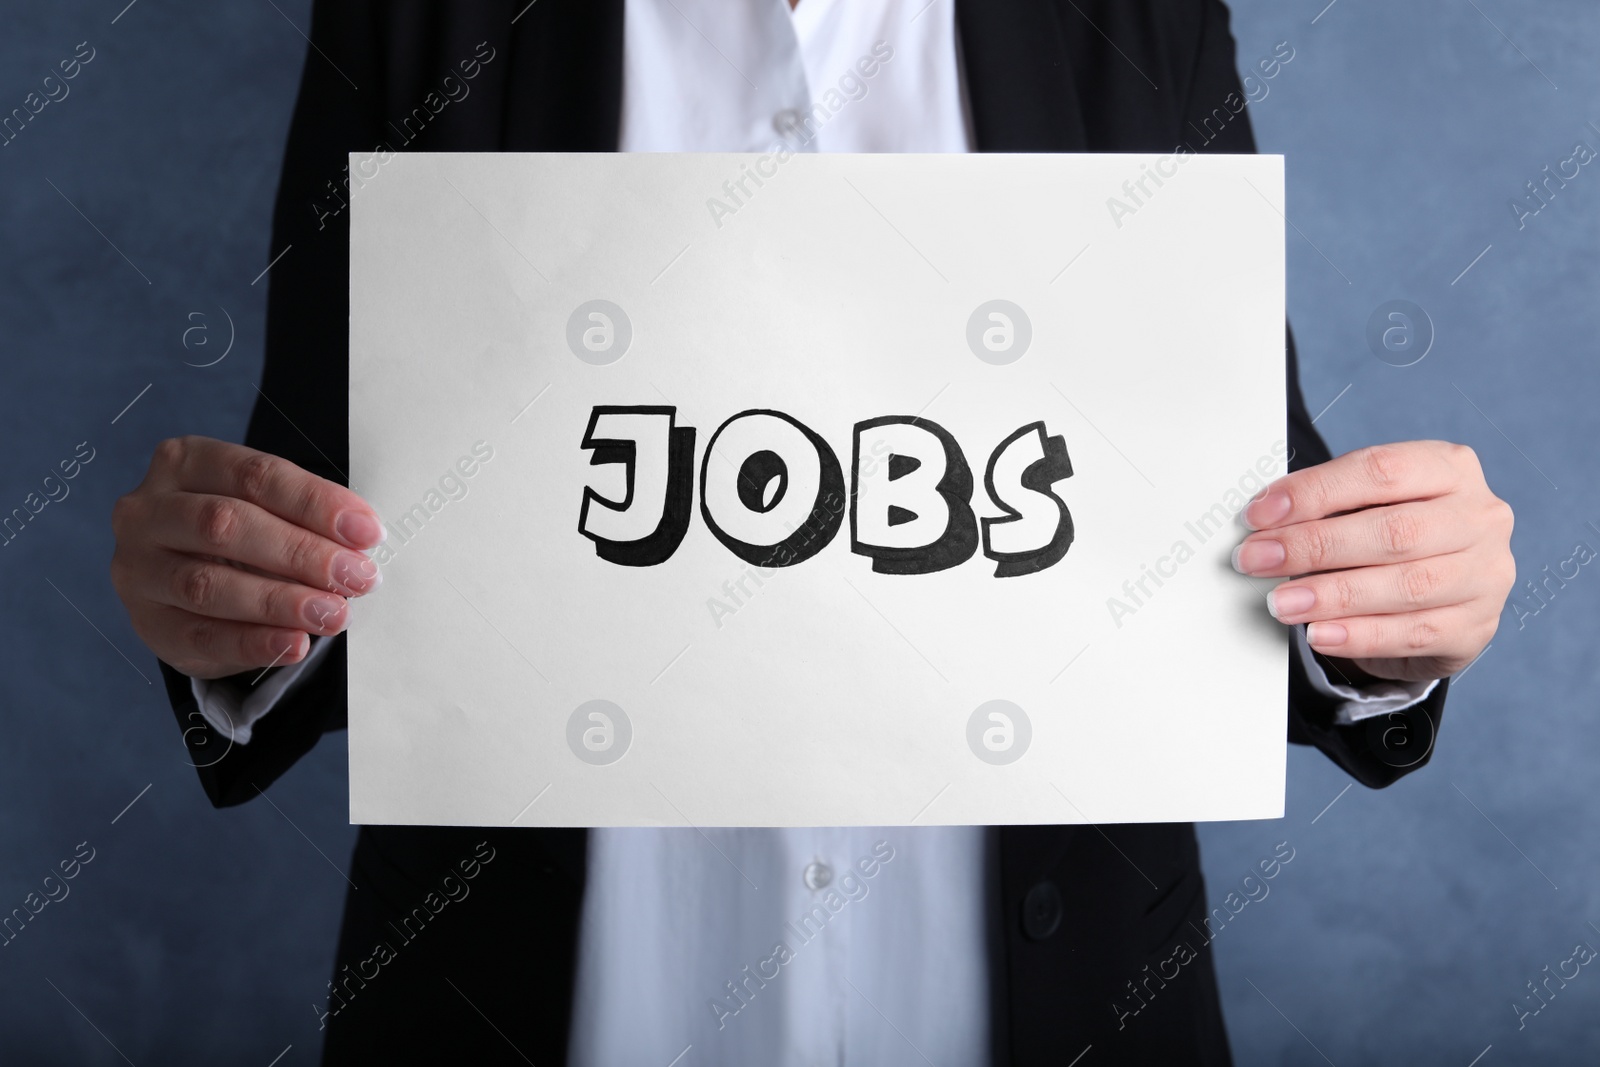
[162,0,384,806]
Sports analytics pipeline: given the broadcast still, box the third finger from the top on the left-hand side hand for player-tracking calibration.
[133,549,350,635]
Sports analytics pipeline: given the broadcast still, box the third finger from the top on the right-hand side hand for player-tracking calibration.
[1267,552,1490,622]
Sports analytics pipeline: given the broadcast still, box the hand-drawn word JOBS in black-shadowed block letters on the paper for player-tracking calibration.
[578,405,1074,577]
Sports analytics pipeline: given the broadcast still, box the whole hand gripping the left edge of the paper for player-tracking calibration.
[110,437,384,678]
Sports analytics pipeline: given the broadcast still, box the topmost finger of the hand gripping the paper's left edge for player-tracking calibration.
[160,437,387,549]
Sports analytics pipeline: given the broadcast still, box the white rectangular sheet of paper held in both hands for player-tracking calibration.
[349,154,1286,825]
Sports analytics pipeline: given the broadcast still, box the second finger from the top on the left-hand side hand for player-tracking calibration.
[149,493,382,597]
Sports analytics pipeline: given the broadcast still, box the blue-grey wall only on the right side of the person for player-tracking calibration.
[1202,0,1600,1067]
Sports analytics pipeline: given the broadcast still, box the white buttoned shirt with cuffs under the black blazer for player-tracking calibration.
[194,0,1435,1067]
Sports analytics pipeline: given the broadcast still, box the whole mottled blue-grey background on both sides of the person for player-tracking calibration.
[0,0,1600,1067]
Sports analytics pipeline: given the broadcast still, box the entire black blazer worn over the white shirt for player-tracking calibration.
[163,0,1445,1065]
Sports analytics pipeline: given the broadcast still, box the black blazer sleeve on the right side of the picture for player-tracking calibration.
[1178,0,1450,789]
